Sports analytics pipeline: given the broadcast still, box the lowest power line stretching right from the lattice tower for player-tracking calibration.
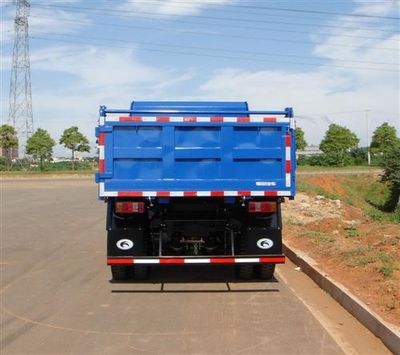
[31,34,398,73]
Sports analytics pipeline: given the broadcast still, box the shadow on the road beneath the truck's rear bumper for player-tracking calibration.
[110,265,280,293]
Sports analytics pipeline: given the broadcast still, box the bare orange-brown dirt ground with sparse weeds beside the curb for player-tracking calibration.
[283,192,400,326]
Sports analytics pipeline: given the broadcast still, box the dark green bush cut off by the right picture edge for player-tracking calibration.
[382,144,400,217]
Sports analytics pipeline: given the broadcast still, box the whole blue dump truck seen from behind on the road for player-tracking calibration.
[96,101,296,281]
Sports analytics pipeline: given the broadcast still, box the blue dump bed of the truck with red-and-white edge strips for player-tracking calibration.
[96,101,296,198]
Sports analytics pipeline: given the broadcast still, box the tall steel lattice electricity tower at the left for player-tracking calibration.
[9,0,33,156]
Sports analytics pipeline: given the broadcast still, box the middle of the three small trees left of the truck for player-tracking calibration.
[26,128,56,170]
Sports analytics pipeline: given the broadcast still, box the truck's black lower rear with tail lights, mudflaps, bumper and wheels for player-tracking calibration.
[107,198,284,280]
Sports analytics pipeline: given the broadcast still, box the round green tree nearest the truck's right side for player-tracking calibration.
[319,124,360,166]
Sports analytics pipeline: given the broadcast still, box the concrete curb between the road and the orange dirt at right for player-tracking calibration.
[283,243,400,355]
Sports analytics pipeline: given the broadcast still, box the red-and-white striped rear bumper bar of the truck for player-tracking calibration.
[107,255,285,265]
